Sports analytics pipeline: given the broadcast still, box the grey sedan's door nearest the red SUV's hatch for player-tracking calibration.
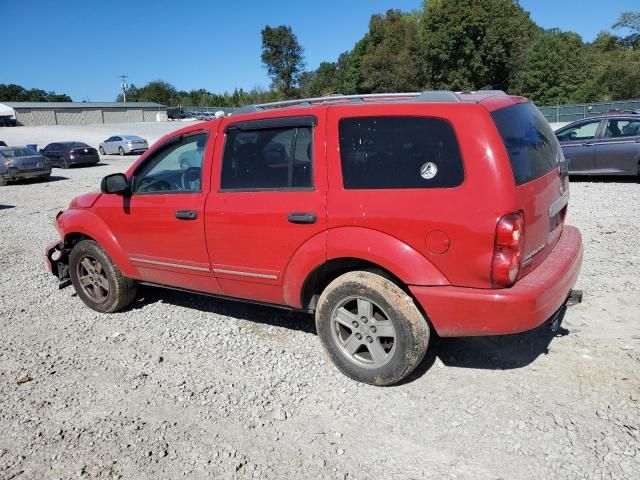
[556,120,602,174]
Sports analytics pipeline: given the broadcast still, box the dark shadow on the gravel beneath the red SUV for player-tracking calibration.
[130,286,569,385]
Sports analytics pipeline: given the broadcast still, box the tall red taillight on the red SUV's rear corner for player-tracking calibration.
[491,212,524,288]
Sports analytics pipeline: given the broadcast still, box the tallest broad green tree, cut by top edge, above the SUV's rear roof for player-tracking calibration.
[419,0,538,90]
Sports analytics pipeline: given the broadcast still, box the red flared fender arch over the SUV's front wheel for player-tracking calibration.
[56,208,138,278]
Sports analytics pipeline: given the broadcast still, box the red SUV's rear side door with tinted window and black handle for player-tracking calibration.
[205,112,327,304]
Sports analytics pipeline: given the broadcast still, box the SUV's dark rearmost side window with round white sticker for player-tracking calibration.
[339,117,464,189]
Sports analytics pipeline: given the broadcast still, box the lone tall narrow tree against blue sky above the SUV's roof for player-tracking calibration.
[261,25,304,97]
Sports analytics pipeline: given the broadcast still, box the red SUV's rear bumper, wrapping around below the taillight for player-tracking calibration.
[409,226,583,337]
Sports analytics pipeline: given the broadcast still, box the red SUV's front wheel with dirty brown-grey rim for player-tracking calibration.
[69,240,138,313]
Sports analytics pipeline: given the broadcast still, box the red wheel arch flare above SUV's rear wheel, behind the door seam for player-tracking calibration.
[327,227,450,286]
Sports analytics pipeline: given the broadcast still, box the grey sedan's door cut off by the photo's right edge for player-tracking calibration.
[595,118,640,174]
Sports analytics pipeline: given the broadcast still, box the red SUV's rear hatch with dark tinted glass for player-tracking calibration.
[491,103,569,278]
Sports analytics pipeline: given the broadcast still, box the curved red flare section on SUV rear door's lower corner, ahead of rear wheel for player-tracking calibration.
[283,230,328,308]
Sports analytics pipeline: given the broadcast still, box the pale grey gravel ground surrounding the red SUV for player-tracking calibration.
[0,157,640,480]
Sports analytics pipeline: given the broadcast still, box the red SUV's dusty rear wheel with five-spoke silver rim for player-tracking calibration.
[316,271,429,386]
